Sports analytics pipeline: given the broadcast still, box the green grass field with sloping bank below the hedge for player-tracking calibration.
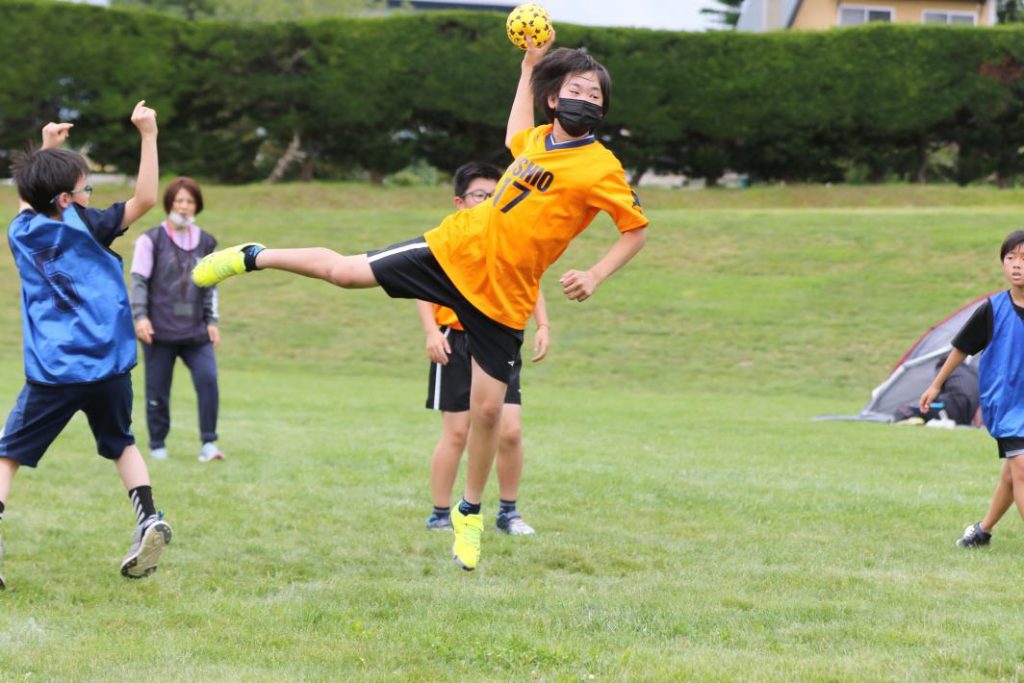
[0,185,1024,681]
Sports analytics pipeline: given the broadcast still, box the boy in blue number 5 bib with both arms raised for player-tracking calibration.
[0,100,171,589]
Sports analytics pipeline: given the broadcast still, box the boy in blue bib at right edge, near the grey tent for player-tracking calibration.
[919,230,1024,548]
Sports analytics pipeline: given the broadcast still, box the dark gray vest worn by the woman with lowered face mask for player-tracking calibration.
[146,225,217,343]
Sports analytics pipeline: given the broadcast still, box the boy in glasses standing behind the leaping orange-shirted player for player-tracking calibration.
[416,162,550,536]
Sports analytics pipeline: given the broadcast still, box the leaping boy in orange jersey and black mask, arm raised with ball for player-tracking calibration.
[193,40,648,570]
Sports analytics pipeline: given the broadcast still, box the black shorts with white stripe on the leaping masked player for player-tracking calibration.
[367,237,522,384]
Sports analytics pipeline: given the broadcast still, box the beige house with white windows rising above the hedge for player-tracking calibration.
[737,0,996,32]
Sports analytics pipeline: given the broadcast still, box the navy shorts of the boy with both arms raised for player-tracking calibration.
[0,373,135,467]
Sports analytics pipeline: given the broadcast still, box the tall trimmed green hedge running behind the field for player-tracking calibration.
[0,0,1024,182]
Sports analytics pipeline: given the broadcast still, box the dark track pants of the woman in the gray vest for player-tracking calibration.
[142,341,220,449]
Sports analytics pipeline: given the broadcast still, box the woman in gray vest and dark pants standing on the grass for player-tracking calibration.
[130,177,224,463]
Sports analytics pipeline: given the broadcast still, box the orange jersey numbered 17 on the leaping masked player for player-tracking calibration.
[424,125,647,330]
